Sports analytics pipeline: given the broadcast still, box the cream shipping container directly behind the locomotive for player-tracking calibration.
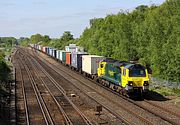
[82,55,105,75]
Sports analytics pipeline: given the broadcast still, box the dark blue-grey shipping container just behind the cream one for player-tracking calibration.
[71,52,88,70]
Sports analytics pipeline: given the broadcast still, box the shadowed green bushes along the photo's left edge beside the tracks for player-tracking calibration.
[0,37,14,124]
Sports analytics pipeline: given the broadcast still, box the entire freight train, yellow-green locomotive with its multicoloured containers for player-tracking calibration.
[30,44,149,97]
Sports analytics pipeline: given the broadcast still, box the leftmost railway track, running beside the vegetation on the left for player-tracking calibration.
[14,51,48,124]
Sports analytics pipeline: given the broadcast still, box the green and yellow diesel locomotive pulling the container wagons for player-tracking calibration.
[98,58,149,95]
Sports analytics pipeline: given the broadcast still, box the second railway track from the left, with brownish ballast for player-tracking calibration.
[16,47,92,125]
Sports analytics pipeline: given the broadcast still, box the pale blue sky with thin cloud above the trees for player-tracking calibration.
[0,0,165,38]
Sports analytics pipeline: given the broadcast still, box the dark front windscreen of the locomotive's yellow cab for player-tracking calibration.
[129,69,146,77]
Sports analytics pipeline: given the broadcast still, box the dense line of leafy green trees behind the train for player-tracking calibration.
[19,0,180,81]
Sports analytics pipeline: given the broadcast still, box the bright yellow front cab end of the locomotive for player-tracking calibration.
[121,64,149,93]
